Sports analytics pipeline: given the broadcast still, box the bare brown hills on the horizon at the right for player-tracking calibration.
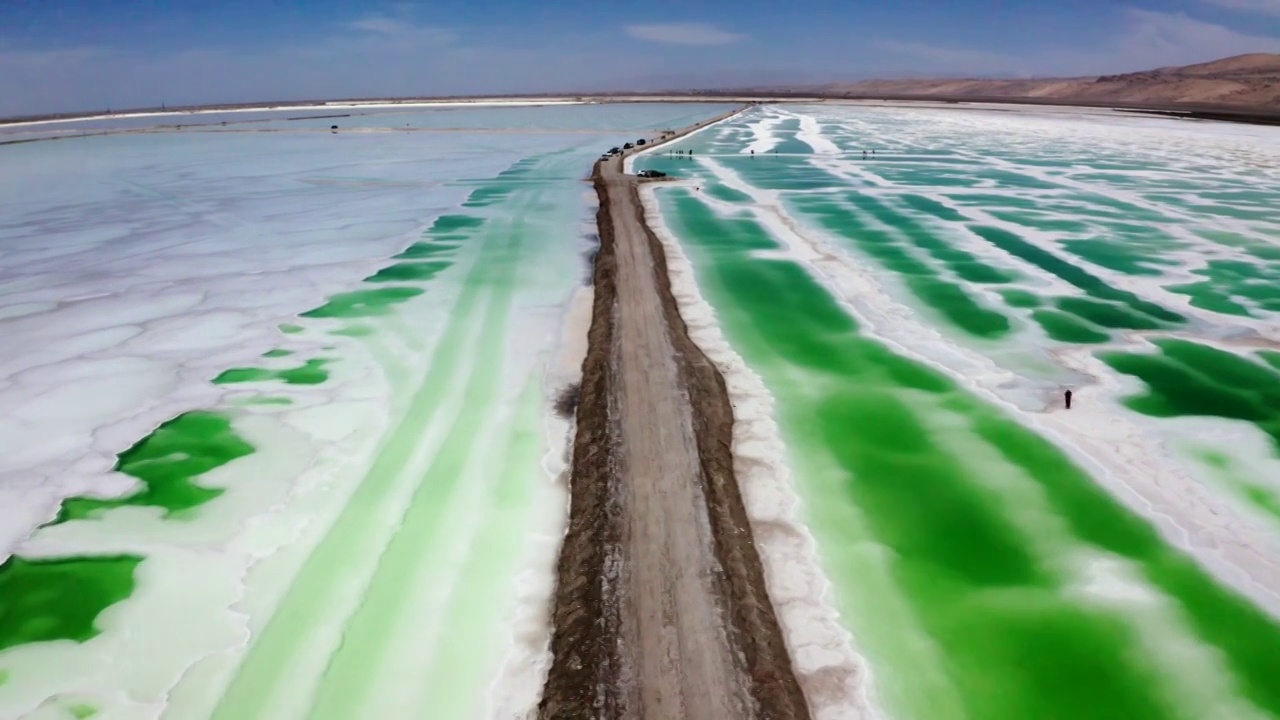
[823,53,1280,110]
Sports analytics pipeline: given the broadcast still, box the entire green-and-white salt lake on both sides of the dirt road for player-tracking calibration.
[10,99,1280,720]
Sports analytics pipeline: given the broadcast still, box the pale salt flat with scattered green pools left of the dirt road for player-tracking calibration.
[0,99,737,719]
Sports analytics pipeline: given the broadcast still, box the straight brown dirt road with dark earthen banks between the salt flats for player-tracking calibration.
[539,114,808,720]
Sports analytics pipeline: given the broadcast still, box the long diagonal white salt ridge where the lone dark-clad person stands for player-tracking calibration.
[699,149,1280,615]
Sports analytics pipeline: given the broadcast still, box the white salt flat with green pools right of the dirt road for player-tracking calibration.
[637,105,1280,719]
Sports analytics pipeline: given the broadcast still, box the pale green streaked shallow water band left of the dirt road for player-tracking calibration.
[214,144,581,720]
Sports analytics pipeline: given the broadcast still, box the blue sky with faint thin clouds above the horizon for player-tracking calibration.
[0,0,1280,115]
